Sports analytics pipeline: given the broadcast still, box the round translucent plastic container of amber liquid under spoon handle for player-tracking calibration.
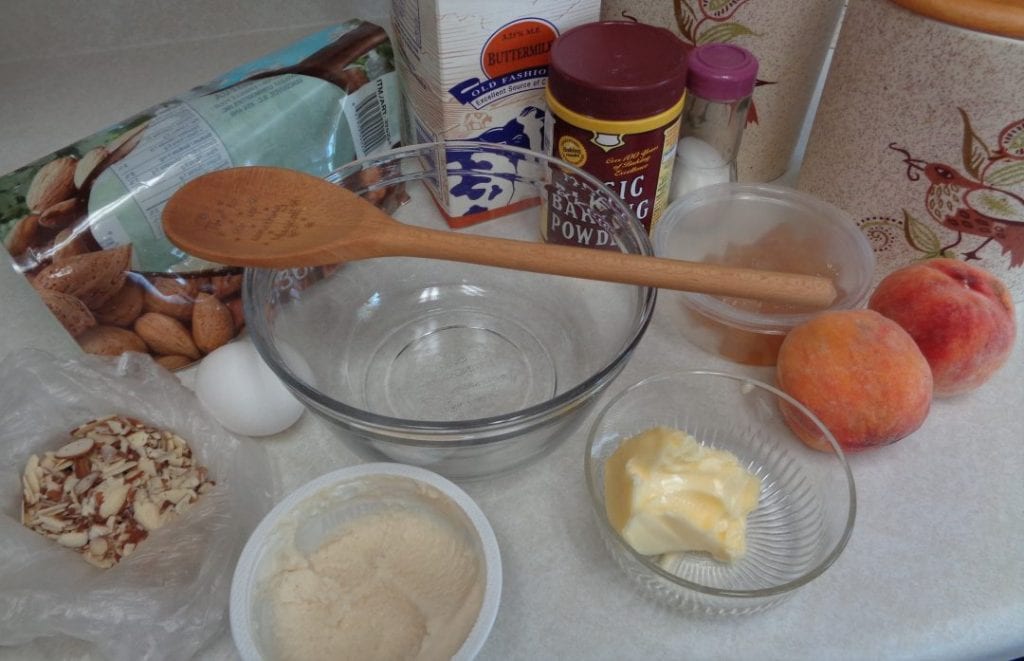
[651,182,874,365]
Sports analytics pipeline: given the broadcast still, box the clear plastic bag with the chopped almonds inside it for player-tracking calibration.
[0,349,280,661]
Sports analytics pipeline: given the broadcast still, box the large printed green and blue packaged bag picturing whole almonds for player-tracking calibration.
[0,20,401,369]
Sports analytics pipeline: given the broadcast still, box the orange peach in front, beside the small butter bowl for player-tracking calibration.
[775,310,932,451]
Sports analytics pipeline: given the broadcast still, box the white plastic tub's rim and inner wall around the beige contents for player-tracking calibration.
[230,462,502,661]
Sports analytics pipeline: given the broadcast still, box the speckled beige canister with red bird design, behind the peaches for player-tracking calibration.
[798,0,1024,302]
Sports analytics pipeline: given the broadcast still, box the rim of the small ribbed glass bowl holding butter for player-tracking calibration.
[584,369,857,599]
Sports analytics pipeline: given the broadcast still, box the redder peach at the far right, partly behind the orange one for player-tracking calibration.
[867,258,1017,397]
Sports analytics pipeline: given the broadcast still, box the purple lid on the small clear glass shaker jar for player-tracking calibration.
[686,44,758,101]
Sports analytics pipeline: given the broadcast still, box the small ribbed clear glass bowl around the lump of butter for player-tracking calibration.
[586,370,856,615]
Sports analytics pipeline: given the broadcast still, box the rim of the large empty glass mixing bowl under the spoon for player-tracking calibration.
[242,140,657,448]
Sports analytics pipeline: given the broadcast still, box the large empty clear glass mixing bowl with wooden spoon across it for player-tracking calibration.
[244,142,655,479]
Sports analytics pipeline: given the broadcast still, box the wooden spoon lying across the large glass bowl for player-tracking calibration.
[157,167,836,308]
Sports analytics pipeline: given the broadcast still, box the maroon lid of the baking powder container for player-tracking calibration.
[548,20,686,120]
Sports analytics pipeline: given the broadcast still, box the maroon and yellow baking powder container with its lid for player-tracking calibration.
[542,20,686,248]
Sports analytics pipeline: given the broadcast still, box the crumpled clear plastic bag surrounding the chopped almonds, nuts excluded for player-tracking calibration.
[0,350,279,661]
